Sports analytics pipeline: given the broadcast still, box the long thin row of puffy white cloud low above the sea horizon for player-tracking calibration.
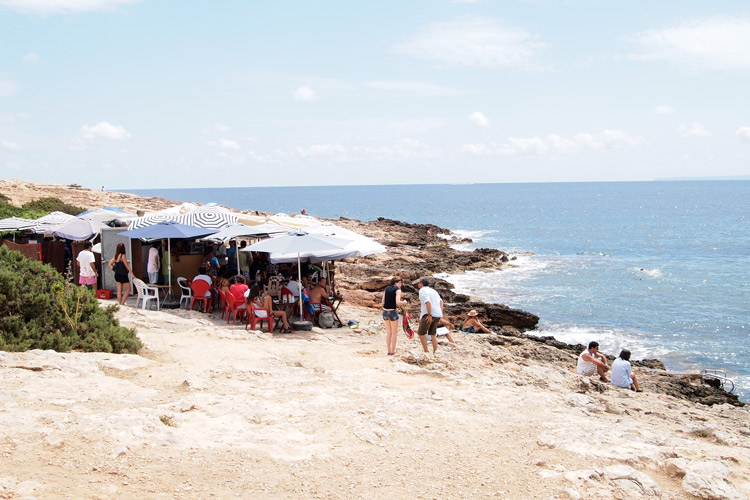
[462,130,644,156]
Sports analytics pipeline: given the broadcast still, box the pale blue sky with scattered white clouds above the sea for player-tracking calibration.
[0,0,750,190]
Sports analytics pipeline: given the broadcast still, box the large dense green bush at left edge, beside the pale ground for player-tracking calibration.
[0,246,142,353]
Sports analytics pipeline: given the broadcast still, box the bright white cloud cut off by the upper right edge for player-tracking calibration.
[627,16,750,69]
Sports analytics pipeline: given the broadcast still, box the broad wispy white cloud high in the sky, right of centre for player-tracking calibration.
[393,18,546,69]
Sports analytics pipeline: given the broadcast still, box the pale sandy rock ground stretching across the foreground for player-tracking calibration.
[0,305,750,499]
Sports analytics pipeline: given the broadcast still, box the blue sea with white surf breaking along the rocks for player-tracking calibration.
[129,181,750,401]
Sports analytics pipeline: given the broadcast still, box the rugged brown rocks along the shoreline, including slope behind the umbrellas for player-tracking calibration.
[0,180,744,406]
